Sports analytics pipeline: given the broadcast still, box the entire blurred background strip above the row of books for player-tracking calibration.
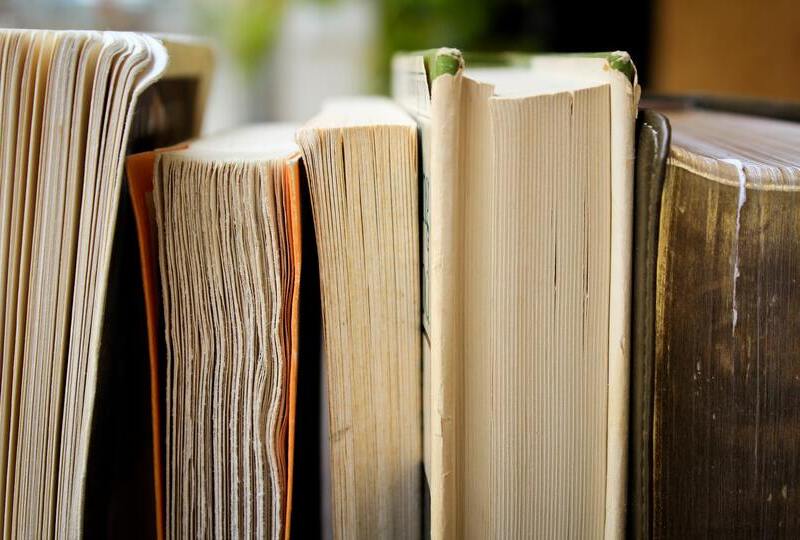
[0,0,800,131]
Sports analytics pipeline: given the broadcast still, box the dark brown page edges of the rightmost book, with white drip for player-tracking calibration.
[653,144,800,538]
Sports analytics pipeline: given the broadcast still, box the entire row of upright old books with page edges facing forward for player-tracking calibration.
[0,30,800,538]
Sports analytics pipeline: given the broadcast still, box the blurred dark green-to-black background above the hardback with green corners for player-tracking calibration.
[377,0,652,88]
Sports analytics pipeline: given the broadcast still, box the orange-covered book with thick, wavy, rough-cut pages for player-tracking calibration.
[128,125,302,538]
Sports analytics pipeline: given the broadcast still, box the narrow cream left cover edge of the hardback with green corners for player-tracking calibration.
[428,73,464,538]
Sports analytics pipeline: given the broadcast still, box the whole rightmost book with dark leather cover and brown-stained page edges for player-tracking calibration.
[630,100,800,538]
